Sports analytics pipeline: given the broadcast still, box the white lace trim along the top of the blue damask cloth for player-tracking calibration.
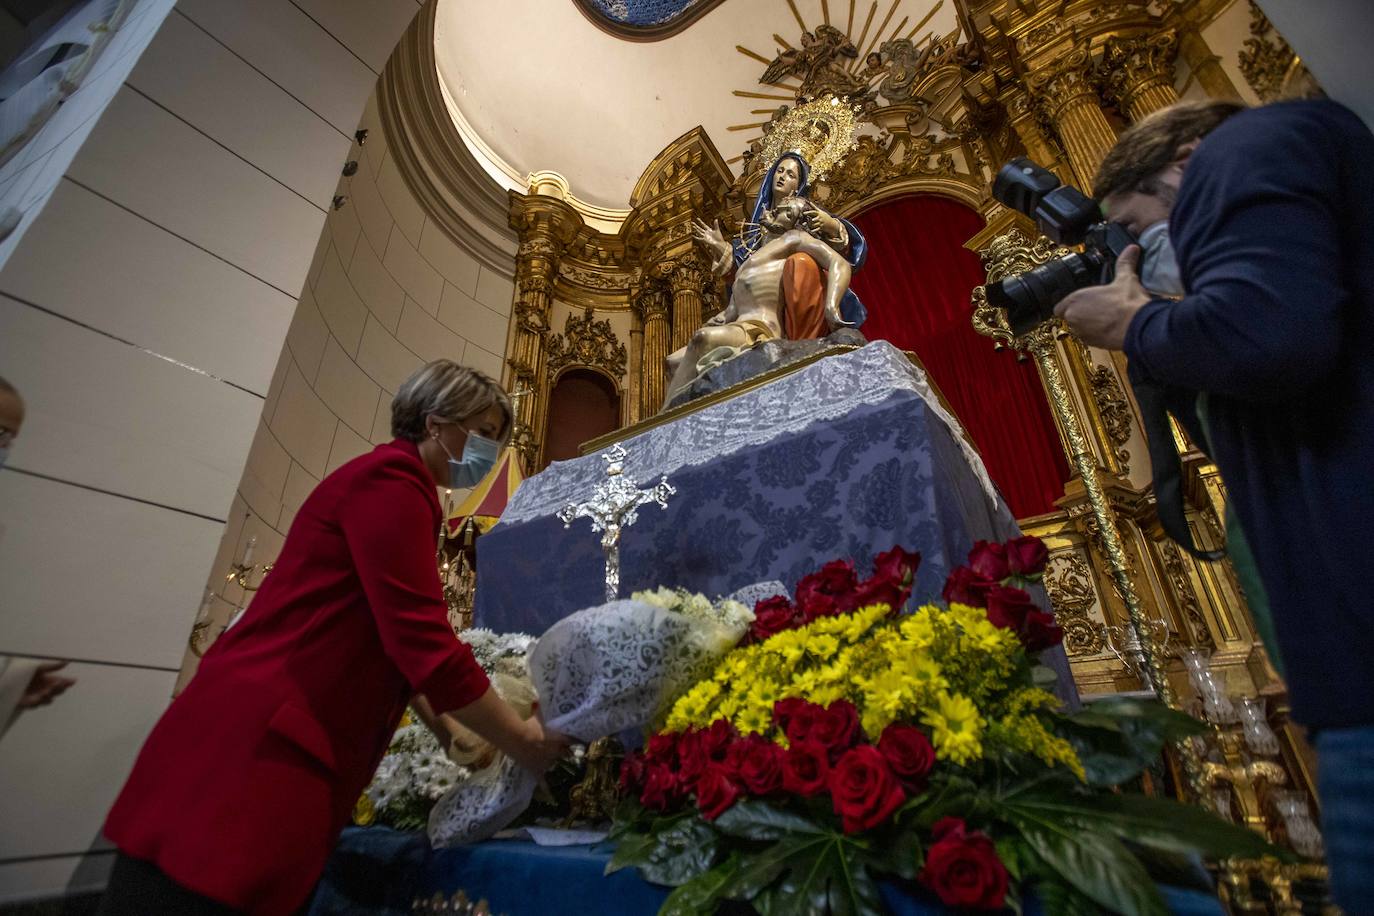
[500,341,1002,526]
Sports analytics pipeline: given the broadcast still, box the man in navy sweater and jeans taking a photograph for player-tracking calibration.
[1055,100,1374,912]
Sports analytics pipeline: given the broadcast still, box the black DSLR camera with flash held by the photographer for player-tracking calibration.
[987,157,1135,335]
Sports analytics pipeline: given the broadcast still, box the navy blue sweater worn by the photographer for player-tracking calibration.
[1125,100,1374,728]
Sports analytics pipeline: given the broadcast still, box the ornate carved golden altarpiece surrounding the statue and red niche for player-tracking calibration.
[379,0,1315,912]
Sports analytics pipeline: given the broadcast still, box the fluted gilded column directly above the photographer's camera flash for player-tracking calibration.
[1029,48,1116,192]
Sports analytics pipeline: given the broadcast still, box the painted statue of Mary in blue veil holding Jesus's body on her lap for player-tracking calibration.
[664,154,867,408]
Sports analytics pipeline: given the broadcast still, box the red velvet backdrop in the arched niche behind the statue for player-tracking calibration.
[852,195,1069,518]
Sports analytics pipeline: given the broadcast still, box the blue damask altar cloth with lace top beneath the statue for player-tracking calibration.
[474,341,1072,695]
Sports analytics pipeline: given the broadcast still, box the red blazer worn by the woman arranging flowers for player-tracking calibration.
[104,439,488,916]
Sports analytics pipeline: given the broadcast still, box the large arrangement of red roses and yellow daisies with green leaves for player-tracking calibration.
[610,537,1274,915]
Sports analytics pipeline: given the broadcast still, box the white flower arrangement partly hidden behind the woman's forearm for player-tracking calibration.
[353,629,534,829]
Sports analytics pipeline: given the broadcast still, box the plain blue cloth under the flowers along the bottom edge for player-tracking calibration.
[309,827,1223,916]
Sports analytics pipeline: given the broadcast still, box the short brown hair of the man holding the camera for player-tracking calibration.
[1092,99,1245,201]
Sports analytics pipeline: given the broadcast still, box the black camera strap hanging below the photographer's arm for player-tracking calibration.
[1131,378,1226,560]
